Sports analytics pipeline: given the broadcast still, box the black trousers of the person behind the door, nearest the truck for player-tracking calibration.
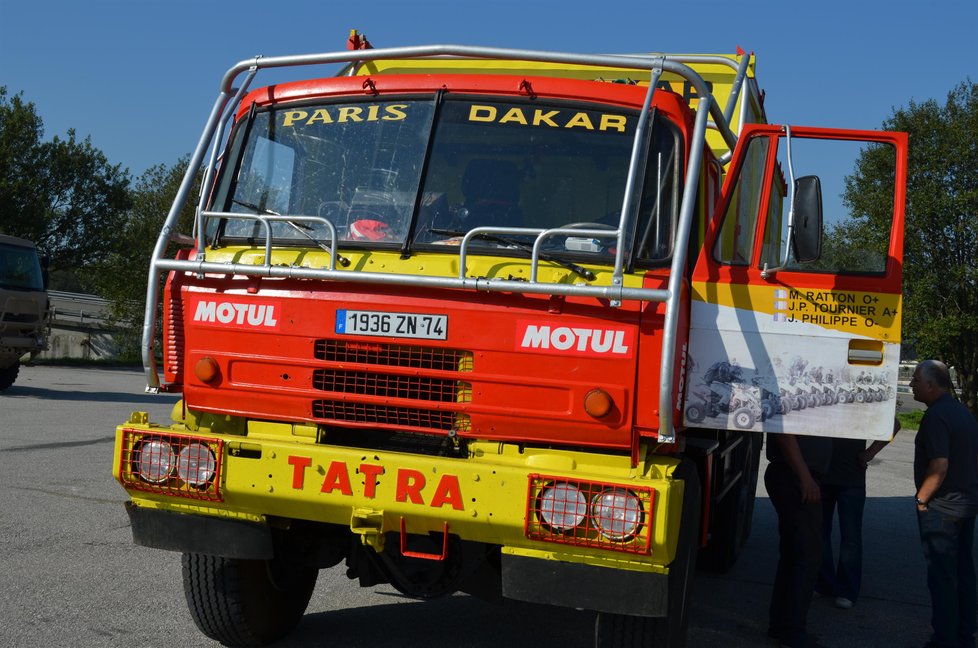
[764,463,822,645]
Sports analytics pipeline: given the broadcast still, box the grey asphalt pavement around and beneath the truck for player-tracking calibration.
[0,366,930,648]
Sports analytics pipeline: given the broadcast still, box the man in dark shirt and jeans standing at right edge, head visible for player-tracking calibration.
[910,360,978,648]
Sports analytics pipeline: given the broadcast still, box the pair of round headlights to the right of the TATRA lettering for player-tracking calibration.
[539,482,644,542]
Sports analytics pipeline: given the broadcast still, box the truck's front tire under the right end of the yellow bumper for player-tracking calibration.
[594,460,703,648]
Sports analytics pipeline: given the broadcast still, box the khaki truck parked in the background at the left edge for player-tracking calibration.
[0,234,49,391]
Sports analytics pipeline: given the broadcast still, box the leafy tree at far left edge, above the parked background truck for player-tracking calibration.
[0,86,130,284]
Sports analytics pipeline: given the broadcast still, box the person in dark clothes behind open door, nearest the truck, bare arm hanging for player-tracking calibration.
[764,433,832,648]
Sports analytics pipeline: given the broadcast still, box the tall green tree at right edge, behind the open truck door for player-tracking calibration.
[845,81,978,416]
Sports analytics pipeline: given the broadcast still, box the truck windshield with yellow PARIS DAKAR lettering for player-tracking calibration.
[209,97,682,262]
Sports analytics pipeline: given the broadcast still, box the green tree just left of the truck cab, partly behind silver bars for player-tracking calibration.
[97,158,200,359]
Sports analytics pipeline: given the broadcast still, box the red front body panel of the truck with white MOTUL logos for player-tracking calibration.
[168,279,648,449]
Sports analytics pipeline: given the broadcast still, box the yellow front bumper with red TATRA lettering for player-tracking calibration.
[113,413,683,571]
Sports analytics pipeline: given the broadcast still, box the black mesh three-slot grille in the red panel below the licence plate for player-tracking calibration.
[312,340,473,432]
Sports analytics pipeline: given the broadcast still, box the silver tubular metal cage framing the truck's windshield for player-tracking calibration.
[142,45,750,443]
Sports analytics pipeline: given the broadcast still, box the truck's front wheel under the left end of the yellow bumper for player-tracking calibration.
[183,554,319,646]
